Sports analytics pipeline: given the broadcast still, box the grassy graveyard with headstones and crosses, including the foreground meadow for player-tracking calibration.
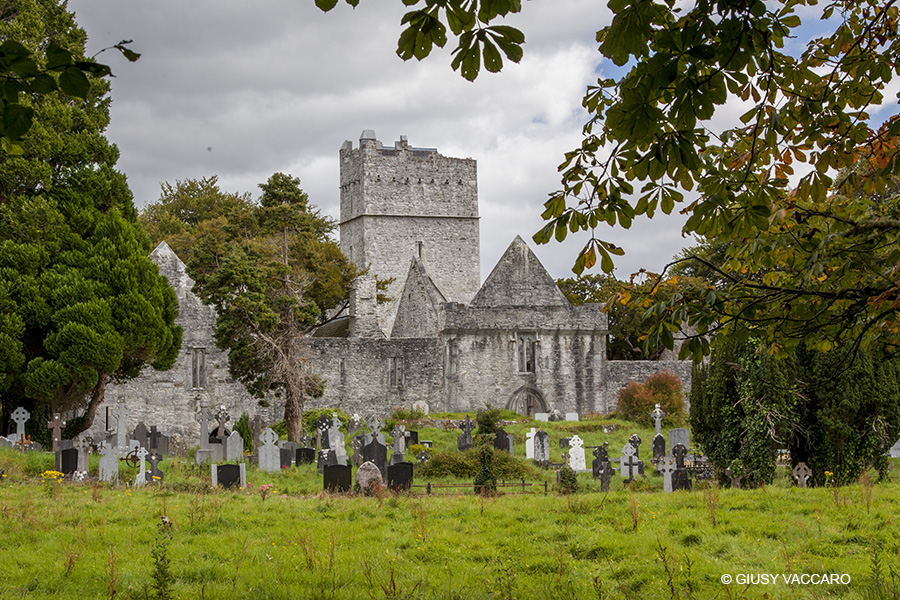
[0,410,900,599]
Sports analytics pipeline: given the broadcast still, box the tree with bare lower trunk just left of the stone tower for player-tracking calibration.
[176,173,357,441]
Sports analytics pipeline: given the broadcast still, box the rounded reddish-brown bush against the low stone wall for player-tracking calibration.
[616,371,685,427]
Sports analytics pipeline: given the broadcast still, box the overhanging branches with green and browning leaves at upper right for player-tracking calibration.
[316,0,900,359]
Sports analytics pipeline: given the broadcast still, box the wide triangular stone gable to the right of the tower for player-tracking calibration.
[472,236,570,308]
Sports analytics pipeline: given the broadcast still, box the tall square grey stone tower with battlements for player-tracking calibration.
[340,129,480,335]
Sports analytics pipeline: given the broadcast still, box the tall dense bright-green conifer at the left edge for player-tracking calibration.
[0,0,181,435]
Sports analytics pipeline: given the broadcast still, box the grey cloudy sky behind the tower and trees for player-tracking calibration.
[69,0,690,278]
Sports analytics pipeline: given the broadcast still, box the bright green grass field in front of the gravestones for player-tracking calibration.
[0,414,900,599]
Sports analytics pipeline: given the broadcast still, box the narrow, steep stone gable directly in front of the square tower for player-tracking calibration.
[391,258,447,338]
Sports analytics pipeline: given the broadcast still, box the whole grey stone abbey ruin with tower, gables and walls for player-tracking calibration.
[93,130,690,437]
